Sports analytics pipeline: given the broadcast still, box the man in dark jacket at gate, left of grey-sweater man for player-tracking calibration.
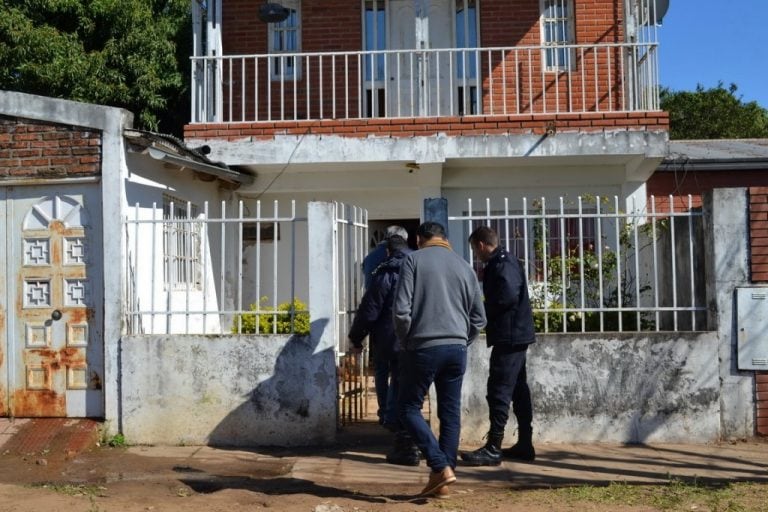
[349,235,418,432]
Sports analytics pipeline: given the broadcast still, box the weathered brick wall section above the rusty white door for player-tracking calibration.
[0,116,101,180]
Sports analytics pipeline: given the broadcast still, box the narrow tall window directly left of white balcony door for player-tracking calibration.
[363,0,387,117]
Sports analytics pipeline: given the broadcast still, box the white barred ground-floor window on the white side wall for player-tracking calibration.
[163,195,202,290]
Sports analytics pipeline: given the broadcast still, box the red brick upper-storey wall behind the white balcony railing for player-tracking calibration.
[216,0,636,122]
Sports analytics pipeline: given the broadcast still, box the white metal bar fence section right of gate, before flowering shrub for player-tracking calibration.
[449,196,706,332]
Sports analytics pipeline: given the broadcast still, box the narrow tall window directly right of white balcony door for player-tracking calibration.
[456,0,480,116]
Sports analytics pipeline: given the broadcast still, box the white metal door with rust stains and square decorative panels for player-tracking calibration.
[5,184,104,417]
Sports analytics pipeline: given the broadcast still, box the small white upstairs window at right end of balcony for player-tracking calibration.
[541,0,574,71]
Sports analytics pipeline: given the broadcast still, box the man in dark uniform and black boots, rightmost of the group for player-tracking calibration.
[461,226,536,466]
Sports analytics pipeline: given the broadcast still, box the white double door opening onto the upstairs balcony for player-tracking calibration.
[386,0,455,117]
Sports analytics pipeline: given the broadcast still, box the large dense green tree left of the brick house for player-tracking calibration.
[0,0,191,133]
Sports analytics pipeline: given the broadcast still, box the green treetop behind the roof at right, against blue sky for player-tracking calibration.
[661,82,768,139]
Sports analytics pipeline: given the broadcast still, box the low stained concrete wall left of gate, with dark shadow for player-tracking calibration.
[120,326,336,446]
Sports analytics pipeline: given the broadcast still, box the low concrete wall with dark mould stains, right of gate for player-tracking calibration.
[450,332,720,444]
